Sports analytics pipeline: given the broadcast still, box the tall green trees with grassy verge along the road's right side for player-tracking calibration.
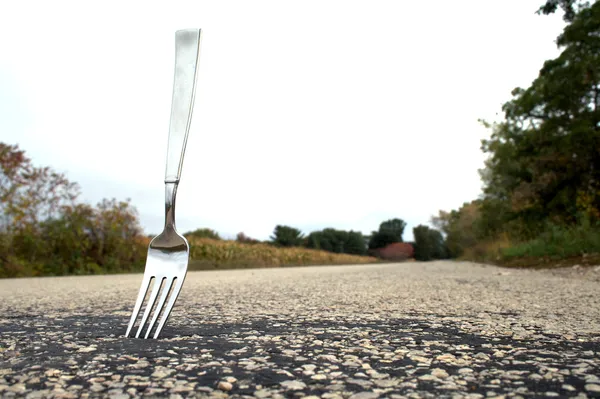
[431,0,600,266]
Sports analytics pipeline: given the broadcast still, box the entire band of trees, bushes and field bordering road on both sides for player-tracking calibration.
[0,0,600,277]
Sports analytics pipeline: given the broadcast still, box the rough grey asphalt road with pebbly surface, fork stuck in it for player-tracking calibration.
[0,262,600,399]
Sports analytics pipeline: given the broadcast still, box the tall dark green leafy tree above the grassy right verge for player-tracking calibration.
[481,1,600,239]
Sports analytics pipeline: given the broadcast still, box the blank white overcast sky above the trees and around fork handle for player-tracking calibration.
[0,0,564,240]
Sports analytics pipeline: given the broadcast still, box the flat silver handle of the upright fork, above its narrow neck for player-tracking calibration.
[165,29,200,183]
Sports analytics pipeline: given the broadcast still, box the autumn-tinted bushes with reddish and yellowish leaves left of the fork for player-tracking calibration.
[0,143,147,277]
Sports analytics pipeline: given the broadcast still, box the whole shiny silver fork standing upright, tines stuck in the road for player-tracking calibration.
[125,29,201,339]
